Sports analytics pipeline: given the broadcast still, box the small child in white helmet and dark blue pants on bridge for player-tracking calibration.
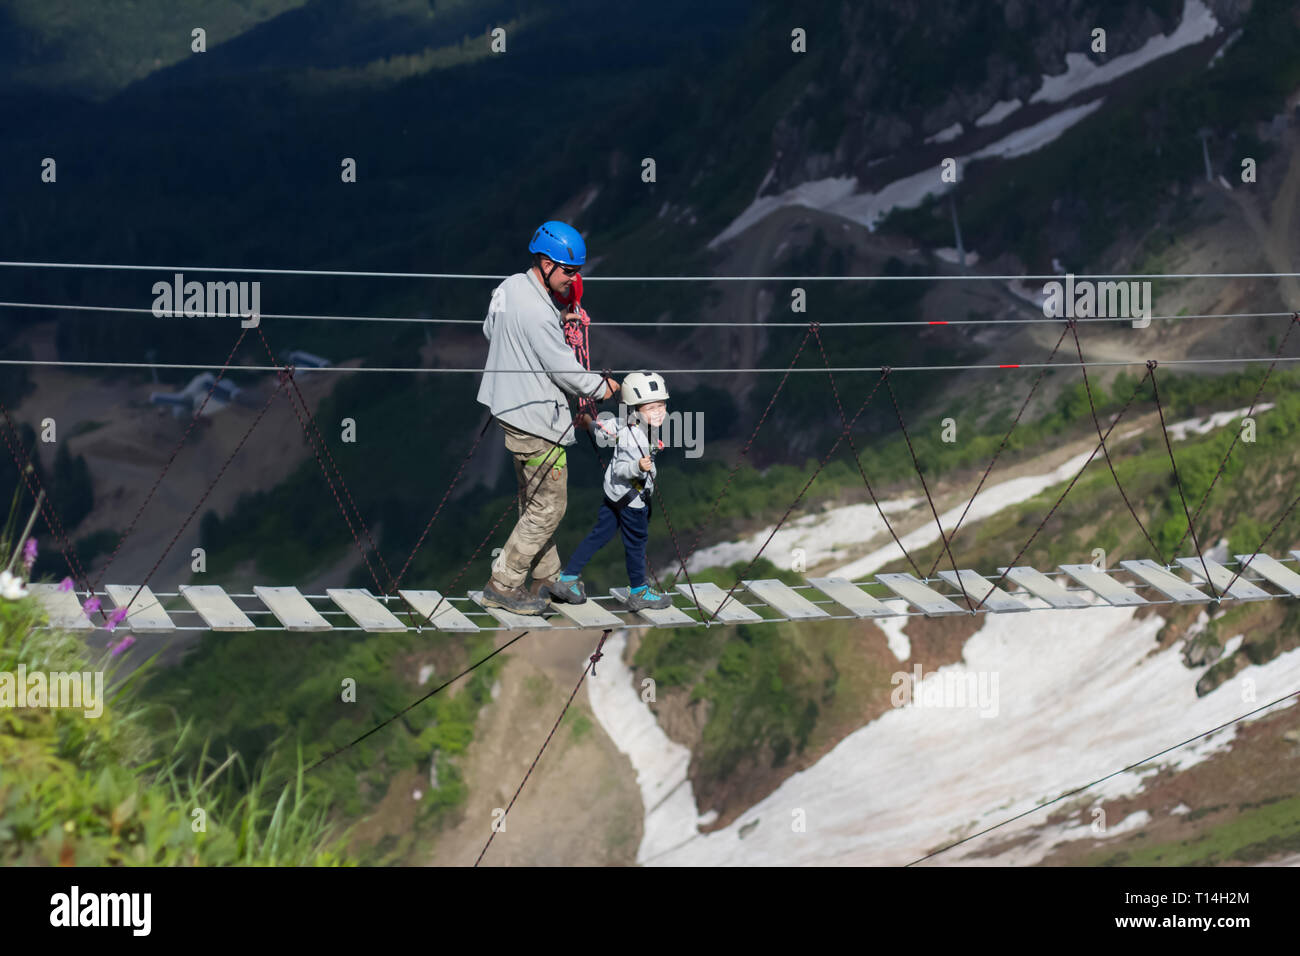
[549,372,672,611]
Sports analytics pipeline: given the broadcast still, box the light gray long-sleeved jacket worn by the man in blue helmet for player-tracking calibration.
[478,269,605,445]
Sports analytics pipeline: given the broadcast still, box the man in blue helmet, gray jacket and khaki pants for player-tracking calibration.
[478,221,619,614]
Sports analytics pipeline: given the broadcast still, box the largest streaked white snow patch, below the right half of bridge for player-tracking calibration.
[644,606,1300,866]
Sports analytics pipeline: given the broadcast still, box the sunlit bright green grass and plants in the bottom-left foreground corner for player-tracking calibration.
[0,496,351,866]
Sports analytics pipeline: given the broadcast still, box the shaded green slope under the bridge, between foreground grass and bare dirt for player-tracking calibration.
[147,632,501,827]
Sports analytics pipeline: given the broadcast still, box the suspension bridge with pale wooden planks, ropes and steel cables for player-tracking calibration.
[0,261,1300,860]
